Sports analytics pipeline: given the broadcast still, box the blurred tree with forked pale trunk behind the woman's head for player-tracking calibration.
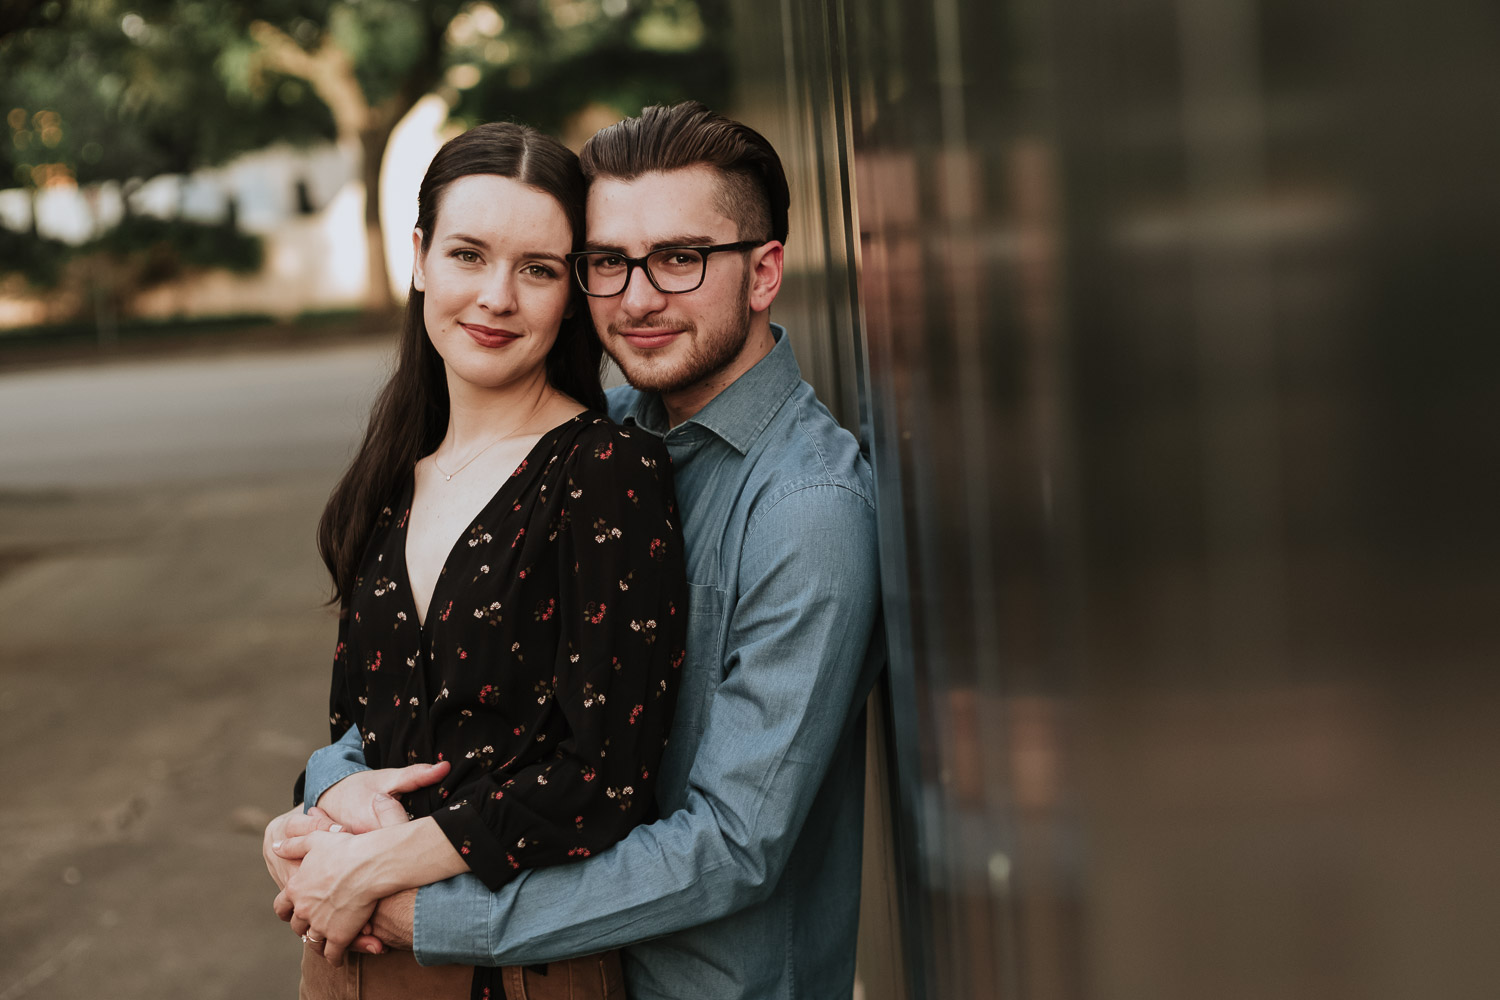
[228,0,729,309]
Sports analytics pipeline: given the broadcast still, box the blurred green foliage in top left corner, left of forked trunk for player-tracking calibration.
[0,0,333,187]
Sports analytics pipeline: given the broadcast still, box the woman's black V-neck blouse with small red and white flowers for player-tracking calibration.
[330,412,687,889]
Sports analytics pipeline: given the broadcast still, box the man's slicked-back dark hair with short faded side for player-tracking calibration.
[579,100,792,243]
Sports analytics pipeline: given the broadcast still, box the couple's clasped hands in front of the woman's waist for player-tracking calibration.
[261,762,449,966]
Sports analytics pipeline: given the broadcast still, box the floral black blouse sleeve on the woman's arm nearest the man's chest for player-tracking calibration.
[434,427,687,889]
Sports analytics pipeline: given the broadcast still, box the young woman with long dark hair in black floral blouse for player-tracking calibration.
[267,124,686,1000]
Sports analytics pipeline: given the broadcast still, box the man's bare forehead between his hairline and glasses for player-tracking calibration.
[588,165,737,243]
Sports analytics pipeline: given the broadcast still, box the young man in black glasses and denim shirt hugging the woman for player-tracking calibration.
[288,103,882,1000]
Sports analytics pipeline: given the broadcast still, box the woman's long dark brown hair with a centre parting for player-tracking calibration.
[318,121,605,613]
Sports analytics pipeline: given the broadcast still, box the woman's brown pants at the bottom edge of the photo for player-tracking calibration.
[297,946,626,1000]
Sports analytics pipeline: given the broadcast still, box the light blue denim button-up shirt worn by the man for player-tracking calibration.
[308,327,884,1000]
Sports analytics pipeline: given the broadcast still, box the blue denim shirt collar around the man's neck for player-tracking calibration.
[626,322,803,454]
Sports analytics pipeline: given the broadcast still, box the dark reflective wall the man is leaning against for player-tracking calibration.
[737,0,1500,1000]
